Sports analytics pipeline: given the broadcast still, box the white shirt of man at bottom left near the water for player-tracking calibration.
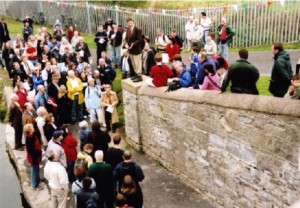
[44,161,69,190]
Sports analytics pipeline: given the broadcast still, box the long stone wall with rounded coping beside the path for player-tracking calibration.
[122,80,300,208]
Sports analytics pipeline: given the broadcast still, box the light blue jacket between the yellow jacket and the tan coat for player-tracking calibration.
[84,85,101,109]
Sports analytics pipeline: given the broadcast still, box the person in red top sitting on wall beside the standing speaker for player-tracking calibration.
[146,53,173,87]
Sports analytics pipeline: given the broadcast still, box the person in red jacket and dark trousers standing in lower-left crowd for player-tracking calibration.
[61,128,78,183]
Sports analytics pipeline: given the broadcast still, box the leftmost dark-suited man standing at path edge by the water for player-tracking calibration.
[9,94,24,151]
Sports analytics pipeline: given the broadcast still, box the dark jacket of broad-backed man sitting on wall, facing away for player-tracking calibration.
[221,59,259,95]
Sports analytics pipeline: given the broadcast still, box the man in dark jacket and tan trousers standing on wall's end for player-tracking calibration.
[125,18,143,82]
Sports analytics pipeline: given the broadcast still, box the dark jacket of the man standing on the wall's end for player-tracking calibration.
[125,26,144,55]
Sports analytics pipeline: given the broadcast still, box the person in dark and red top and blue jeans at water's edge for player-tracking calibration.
[24,124,42,191]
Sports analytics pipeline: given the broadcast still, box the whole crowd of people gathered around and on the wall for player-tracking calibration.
[0,8,300,208]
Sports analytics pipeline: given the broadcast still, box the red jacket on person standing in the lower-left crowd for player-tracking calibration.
[61,133,78,162]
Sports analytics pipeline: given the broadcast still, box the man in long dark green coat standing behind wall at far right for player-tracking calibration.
[269,43,293,97]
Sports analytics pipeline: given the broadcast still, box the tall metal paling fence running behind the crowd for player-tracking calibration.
[0,0,300,47]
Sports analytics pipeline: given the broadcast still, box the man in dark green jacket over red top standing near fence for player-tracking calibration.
[217,17,235,60]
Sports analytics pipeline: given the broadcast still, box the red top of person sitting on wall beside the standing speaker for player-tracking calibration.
[150,64,173,87]
